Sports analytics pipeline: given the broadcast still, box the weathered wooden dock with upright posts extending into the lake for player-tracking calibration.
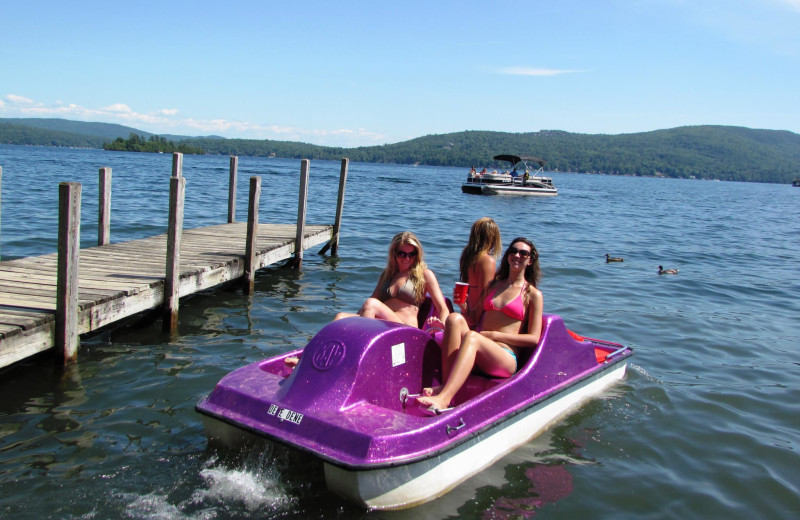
[0,154,347,368]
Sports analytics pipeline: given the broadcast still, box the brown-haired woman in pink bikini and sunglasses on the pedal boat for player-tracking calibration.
[417,237,544,413]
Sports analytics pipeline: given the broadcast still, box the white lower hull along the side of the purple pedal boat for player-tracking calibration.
[325,363,626,509]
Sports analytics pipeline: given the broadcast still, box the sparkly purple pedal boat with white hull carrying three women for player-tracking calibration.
[196,314,633,509]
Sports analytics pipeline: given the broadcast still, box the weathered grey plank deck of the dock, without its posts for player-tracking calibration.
[0,222,331,367]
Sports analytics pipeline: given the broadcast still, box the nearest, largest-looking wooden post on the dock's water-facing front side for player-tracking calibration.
[55,182,81,365]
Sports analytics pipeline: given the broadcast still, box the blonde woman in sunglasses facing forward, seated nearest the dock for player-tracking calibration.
[334,231,450,328]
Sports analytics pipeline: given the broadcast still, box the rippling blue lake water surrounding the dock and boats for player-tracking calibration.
[0,145,800,520]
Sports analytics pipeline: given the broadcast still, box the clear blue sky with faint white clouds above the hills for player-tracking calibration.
[0,0,800,147]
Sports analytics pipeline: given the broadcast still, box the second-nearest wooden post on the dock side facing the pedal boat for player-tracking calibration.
[162,152,186,334]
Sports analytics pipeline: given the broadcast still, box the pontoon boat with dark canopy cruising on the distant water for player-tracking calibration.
[461,155,558,196]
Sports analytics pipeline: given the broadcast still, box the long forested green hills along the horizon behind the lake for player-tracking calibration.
[0,119,800,183]
